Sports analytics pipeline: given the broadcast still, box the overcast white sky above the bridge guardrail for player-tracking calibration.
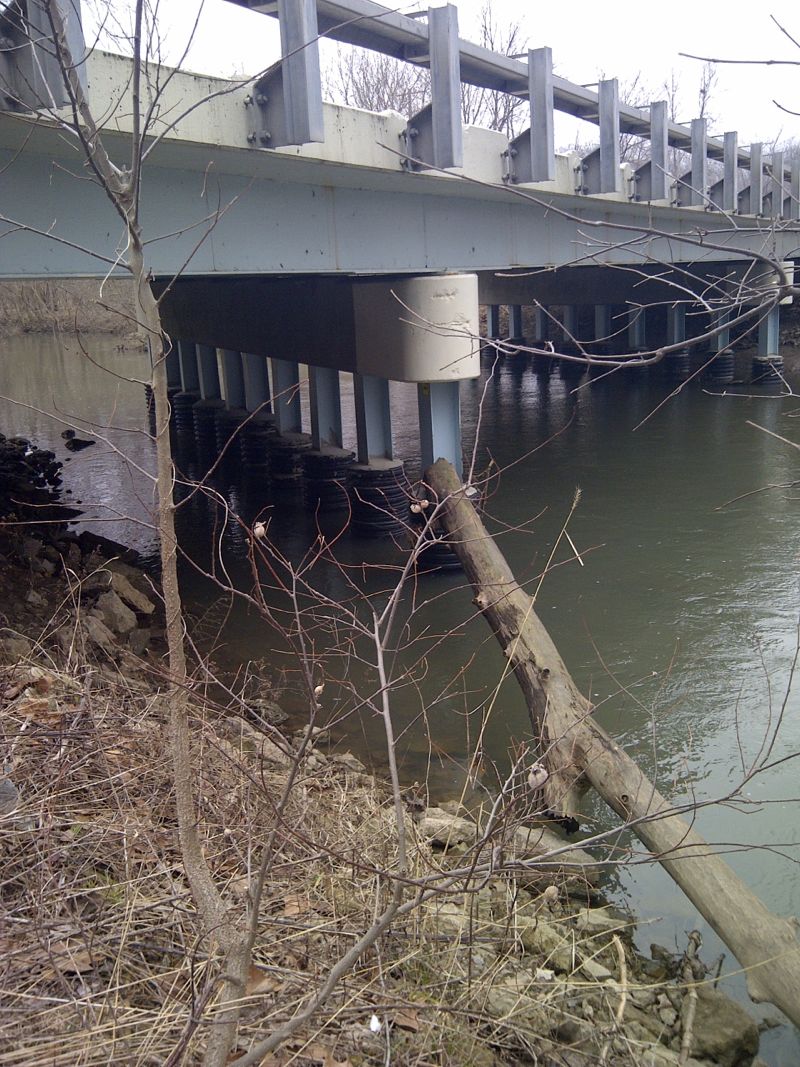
[114,0,800,145]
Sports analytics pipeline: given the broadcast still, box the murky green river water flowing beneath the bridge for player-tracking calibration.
[0,336,800,1067]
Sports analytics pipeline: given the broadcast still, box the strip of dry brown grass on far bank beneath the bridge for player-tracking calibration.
[0,278,135,336]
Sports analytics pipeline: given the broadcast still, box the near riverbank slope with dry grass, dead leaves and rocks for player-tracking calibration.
[0,495,772,1067]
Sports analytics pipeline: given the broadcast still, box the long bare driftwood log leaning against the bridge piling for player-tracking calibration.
[426,460,800,1025]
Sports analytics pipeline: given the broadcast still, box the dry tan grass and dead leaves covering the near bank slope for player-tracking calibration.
[0,644,682,1067]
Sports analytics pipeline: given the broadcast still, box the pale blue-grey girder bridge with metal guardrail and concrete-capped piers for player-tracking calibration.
[0,0,800,524]
